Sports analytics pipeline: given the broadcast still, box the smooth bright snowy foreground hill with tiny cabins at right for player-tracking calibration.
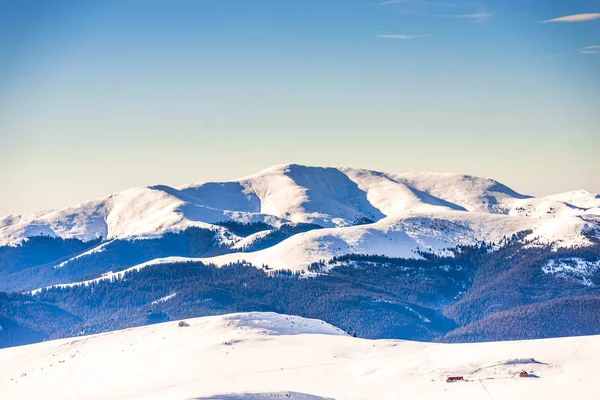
[0,313,600,400]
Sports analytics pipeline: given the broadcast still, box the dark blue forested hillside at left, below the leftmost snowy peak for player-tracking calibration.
[0,221,321,292]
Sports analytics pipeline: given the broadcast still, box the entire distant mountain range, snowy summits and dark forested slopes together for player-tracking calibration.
[0,164,600,347]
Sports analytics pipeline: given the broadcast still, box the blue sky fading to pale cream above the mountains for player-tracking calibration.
[0,0,600,215]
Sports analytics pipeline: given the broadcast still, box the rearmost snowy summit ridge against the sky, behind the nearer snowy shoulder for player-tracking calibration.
[0,164,600,245]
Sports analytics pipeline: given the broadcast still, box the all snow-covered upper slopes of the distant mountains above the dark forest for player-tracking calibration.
[0,164,600,270]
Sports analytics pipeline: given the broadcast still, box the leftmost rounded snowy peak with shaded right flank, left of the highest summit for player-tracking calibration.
[0,186,282,244]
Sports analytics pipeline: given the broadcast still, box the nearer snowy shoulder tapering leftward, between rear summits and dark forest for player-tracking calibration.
[118,212,595,271]
